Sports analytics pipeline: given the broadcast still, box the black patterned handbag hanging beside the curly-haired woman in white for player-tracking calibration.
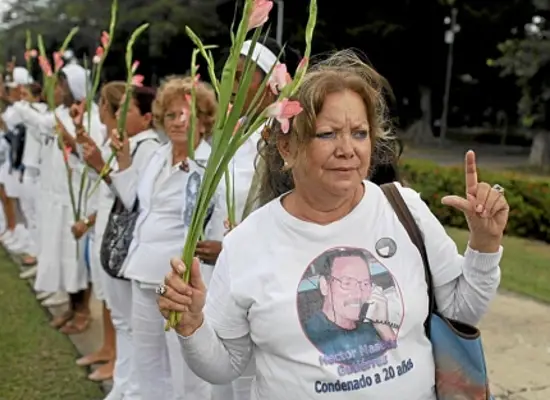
[99,139,158,280]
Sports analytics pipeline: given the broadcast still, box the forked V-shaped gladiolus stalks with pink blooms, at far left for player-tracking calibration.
[38,27,80,221]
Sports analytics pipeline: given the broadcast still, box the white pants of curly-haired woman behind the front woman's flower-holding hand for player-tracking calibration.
[128,281,212,400]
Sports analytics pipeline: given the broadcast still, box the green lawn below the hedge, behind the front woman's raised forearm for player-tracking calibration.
[447,228,550,303]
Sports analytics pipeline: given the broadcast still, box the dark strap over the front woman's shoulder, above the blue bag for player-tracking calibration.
[380,183,437,332]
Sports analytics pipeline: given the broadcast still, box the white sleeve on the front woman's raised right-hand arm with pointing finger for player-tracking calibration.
[400,183,502,325]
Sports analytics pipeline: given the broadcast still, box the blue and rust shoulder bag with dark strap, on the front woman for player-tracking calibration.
[381,183,494,400]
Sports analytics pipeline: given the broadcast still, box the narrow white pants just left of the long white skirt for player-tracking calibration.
[19,167,40,256]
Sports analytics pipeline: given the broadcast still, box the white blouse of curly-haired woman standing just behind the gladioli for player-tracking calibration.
[111,141,227,284]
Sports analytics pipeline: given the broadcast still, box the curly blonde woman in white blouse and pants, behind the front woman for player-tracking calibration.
[110,77,226,400]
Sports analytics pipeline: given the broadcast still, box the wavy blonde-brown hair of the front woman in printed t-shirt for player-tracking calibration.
[257,50,393,205]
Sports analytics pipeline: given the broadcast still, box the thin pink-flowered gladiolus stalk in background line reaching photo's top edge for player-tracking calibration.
[78,0,118,219]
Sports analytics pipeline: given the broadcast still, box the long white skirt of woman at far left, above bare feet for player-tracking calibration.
[34,193,89,293]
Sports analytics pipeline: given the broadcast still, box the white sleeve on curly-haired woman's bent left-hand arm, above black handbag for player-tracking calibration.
[109,140,159,210]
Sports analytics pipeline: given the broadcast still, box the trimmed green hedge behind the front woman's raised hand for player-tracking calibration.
[400,160,550,243]
